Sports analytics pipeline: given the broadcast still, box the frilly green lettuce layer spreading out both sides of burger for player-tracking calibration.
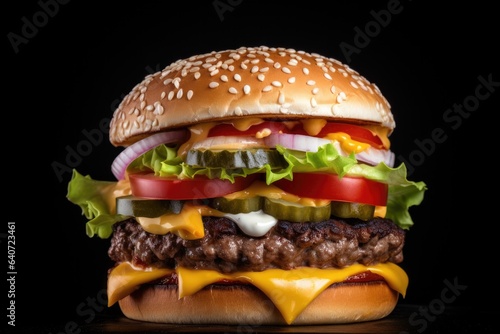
[67,144,427,238]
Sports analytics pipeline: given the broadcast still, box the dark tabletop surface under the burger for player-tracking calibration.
[3,304,498,334]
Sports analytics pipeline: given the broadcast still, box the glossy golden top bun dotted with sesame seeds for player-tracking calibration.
[110,47,395,146]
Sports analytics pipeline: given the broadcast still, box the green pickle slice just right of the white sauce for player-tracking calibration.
[263,198,331,223]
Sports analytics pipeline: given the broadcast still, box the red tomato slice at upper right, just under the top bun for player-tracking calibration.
[292,122,384,149]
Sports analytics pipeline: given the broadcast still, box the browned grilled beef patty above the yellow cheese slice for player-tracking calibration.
[108,217,405,273]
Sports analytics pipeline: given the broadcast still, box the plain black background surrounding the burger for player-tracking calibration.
[4,0,500,330]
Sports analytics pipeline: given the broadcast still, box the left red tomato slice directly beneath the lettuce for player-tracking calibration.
[129,173,258,200]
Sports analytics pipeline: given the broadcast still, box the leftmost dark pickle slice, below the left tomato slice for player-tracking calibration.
[116,195,183,218]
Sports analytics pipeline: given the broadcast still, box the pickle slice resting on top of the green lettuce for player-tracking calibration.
[186,149,286,169]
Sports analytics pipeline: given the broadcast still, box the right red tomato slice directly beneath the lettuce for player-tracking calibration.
[273,173,389,206]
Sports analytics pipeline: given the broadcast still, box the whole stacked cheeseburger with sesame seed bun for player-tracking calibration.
[67,46,426,325]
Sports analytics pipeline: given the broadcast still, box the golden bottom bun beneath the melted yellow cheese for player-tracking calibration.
[119,281,399,325]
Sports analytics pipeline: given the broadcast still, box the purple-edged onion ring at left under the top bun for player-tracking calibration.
[111,130,188,180]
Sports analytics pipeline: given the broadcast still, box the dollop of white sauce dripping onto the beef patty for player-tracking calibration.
[224,210,278,237]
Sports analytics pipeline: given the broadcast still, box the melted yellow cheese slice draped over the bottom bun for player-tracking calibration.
[108,263,408,324]
